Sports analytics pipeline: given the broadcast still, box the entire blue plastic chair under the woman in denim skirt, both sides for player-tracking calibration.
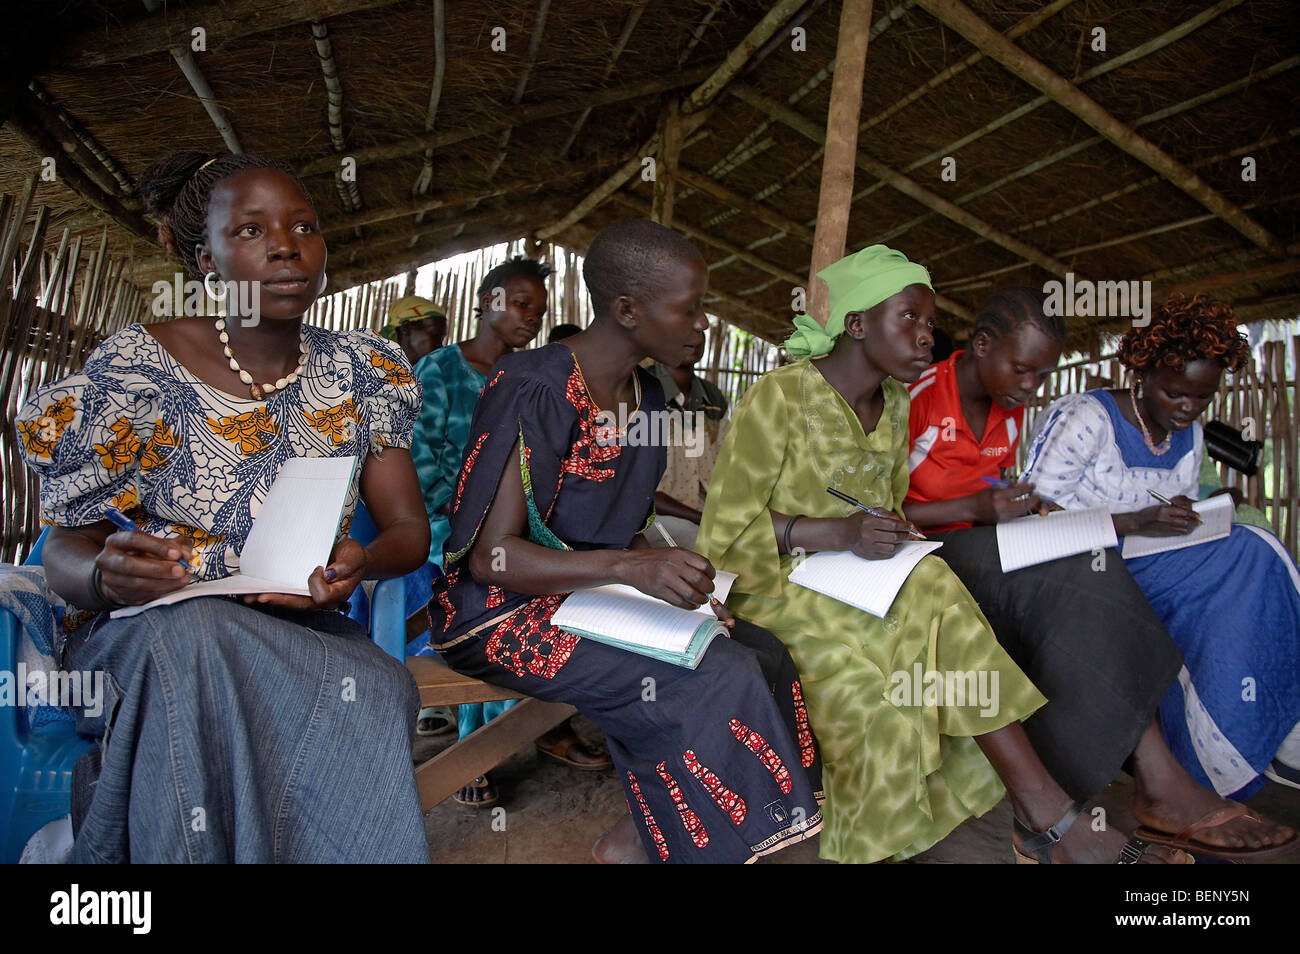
[0,502,406,864]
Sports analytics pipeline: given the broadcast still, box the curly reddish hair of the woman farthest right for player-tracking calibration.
[1118,294,1251,372]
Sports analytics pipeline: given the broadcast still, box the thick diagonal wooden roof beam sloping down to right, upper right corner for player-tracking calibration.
[919,0,1286,259]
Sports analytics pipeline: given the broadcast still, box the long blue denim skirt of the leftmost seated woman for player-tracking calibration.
[64,597,429,863]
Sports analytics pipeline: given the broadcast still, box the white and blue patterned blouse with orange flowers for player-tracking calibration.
[17,325,420,580]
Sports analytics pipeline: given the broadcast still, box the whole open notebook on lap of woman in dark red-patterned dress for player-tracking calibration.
[551,569,736,669]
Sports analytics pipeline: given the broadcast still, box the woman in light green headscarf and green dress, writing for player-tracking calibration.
[697,246,1184,863]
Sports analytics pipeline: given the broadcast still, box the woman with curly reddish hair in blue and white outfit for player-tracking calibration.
[1024,295,1300,805]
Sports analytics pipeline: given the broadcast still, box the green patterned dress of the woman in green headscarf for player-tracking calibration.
[698,359,1045,863]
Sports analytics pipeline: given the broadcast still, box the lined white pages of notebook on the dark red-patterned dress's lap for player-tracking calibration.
[551,584,712,652]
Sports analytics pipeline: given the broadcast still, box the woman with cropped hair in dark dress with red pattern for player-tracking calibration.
[429,220,823,863]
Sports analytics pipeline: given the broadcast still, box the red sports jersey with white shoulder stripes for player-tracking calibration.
[906,351,1024,532]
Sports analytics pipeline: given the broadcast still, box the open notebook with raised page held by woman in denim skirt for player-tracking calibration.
[112,455,356,617]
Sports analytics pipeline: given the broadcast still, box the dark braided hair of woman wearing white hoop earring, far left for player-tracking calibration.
[139,151,312,278]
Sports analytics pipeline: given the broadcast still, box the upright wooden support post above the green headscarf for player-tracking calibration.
[807,0,871,325]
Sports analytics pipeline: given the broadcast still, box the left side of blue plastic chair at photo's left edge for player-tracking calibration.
[0,530,94,864]
